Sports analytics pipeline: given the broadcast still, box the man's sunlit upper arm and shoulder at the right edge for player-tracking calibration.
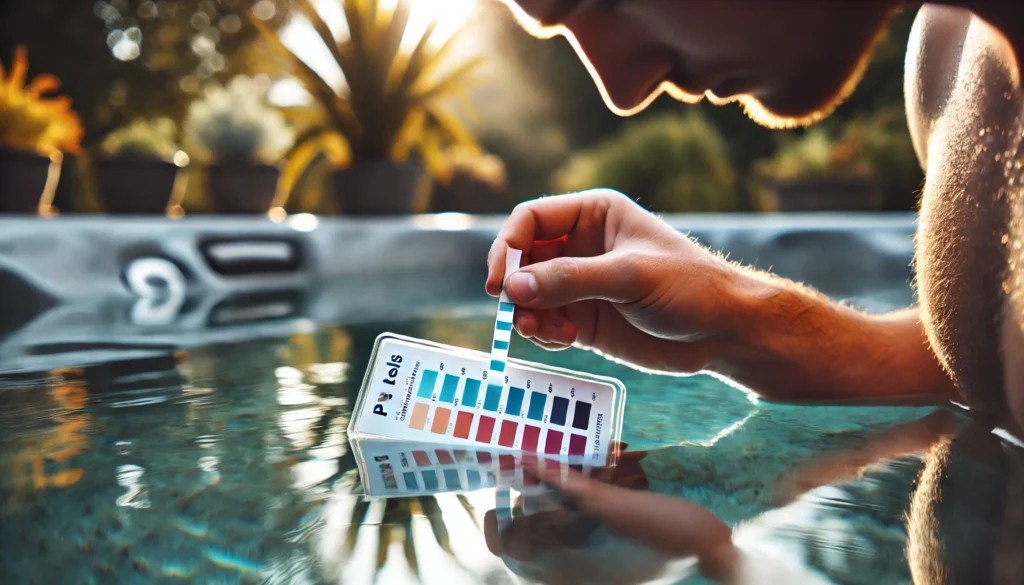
[904,4,1024,420]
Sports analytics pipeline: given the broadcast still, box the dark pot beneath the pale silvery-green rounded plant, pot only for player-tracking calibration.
[206,163,281,214]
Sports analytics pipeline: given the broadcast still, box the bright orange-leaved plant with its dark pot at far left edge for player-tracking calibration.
[0,46,83,213]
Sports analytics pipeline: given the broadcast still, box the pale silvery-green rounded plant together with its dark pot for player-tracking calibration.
[183,76,294,213]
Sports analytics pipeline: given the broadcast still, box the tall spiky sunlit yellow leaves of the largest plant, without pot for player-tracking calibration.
[251,0,479,213]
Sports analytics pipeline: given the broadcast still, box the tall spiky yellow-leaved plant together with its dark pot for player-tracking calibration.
[250,0,478,214]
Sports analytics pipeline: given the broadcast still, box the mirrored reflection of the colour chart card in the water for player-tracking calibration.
[353,438,593,498]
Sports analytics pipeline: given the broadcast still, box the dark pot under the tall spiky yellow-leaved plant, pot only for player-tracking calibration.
[331,161,429,215]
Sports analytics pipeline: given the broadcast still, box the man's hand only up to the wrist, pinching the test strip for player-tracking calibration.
[486,190,749,373]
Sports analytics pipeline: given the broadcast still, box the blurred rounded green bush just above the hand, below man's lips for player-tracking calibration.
[554,110,739,212]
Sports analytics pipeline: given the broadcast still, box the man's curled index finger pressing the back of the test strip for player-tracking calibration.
[486,190,629,294]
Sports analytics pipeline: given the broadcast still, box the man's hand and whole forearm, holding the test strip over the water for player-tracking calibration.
[486,190,956,404]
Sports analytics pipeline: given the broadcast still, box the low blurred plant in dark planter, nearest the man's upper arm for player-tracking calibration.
[751,127,883,211]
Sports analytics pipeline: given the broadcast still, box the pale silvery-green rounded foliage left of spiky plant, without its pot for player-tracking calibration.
[182,76,294,163]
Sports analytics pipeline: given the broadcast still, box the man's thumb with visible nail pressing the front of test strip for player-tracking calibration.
[505,252,643,308]
